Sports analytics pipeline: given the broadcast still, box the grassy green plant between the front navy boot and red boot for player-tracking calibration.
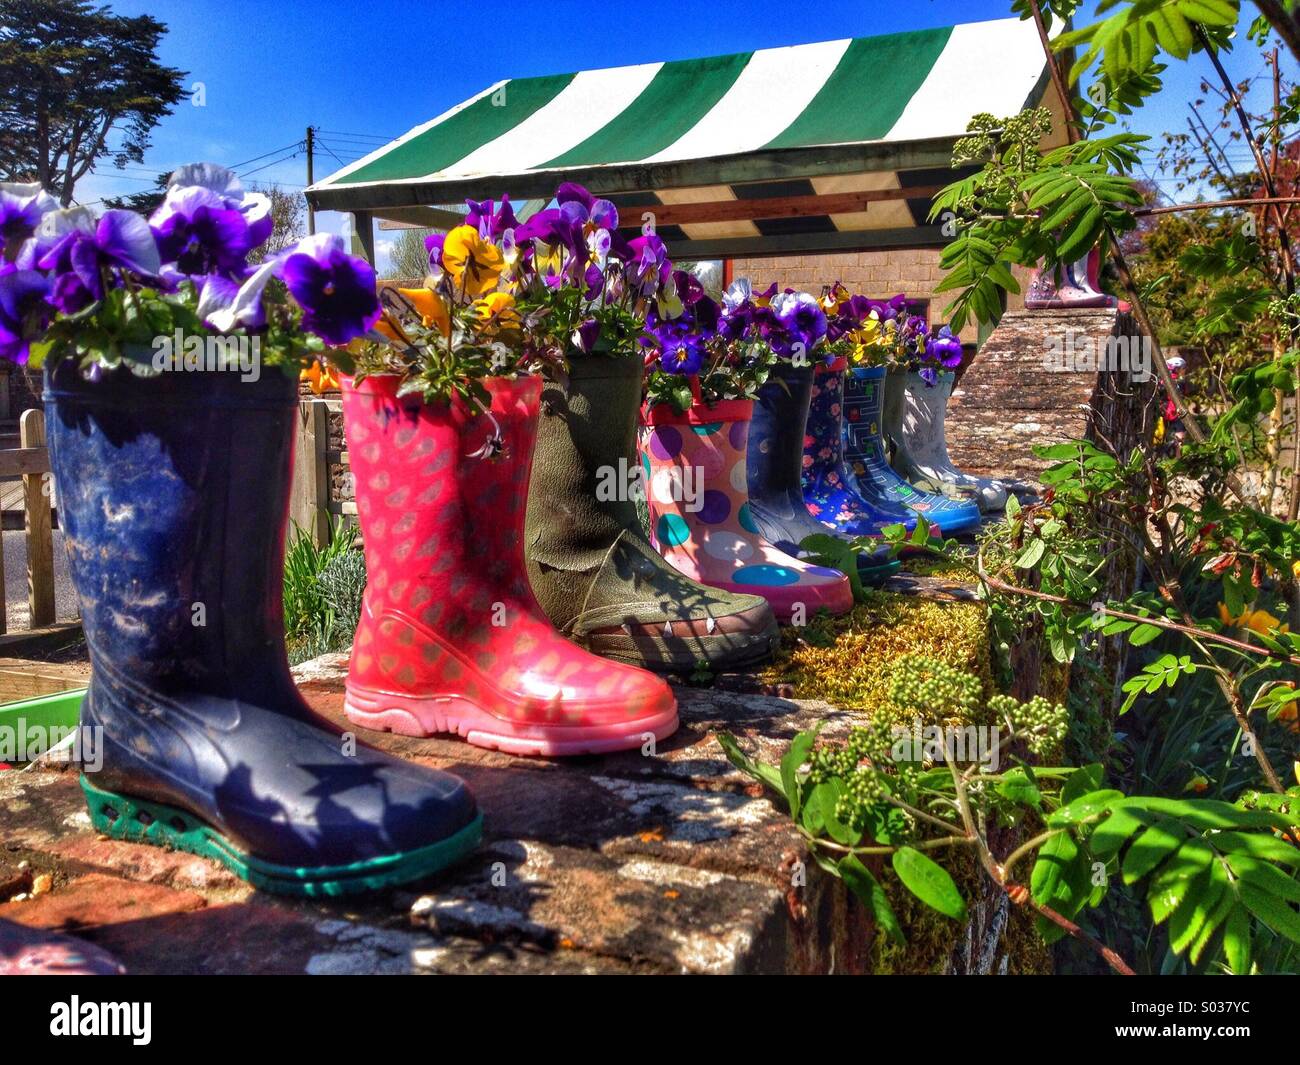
[285,521,365,662]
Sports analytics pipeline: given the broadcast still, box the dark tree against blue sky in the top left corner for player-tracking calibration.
[0,0,186,207]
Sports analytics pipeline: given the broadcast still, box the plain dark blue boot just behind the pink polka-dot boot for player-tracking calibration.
[745,362,900,584]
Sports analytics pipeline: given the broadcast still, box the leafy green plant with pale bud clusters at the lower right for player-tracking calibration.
[718,657,1300,973]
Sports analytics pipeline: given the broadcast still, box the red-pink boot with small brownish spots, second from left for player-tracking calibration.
[343,376,677,754]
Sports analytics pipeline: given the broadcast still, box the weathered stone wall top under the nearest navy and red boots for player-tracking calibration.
[0,655,872,973]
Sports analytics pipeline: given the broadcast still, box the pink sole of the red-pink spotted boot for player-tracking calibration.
[343,685,677,757]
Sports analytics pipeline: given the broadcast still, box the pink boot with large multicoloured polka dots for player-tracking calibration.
[641,399,853,623]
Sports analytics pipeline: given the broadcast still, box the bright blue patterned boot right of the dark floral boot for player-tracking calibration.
[837,367,980,536]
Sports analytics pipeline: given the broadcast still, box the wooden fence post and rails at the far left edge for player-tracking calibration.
[0,410,55,633]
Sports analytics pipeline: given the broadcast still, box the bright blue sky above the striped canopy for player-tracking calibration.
[77,0,1296,265]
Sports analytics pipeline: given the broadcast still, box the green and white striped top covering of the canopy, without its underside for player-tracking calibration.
[308,18,1044,223]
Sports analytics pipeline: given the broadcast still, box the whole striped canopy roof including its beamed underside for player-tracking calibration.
[307,18,1047,257]
